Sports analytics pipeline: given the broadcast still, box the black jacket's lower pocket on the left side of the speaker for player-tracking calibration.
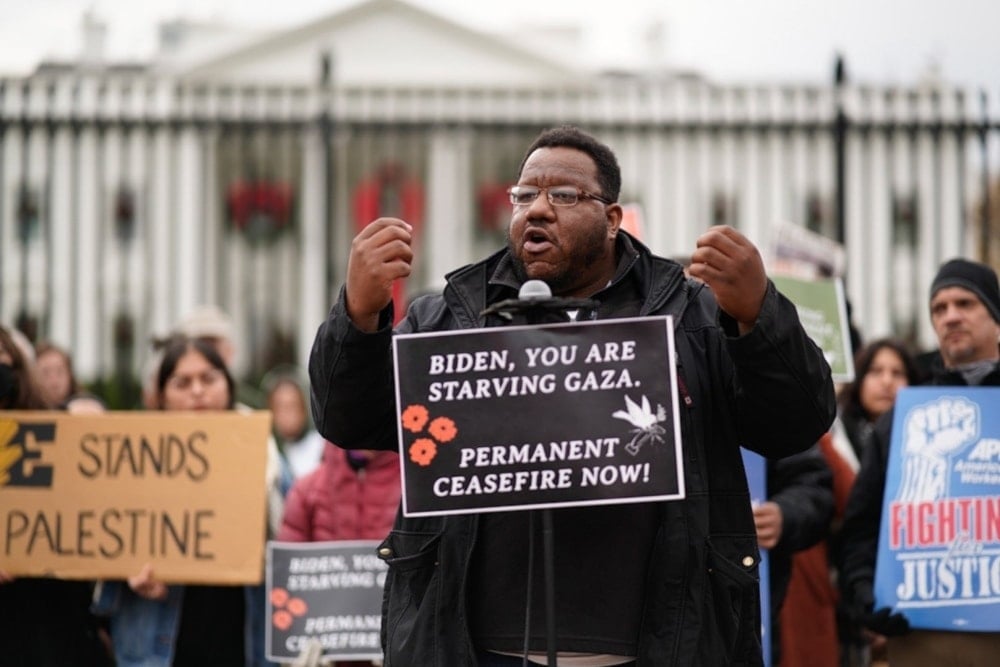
[378,530,441,667]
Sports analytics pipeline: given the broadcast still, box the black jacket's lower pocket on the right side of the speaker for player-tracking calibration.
[708,540,760,665]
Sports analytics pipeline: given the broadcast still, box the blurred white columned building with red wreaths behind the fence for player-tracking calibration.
[0,0,1000,392]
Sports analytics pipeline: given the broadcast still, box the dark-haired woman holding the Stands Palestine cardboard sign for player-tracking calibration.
[96,337,278,667]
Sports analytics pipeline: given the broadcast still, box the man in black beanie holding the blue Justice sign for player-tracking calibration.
[839,259,1000,666]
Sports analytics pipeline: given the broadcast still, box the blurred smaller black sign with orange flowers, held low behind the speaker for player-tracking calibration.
[264,540,386,661]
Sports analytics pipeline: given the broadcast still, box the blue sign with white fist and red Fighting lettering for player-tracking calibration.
[875,387,1000,632]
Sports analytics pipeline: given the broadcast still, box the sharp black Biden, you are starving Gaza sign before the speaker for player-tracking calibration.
[393,317,684,516]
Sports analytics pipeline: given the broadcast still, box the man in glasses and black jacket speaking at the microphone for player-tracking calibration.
[309,127,836,667]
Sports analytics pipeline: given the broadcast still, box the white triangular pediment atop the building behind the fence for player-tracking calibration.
[174,0,584,88]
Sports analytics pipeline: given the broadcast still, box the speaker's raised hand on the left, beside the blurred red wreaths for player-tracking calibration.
[345,218,413,331]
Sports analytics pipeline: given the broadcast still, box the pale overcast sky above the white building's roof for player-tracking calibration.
[0,0,1000,90]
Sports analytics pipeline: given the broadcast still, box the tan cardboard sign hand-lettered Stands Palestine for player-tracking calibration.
[0,411,271,584]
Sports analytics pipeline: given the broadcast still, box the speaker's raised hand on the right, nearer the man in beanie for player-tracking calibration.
[688,226,767,334]
